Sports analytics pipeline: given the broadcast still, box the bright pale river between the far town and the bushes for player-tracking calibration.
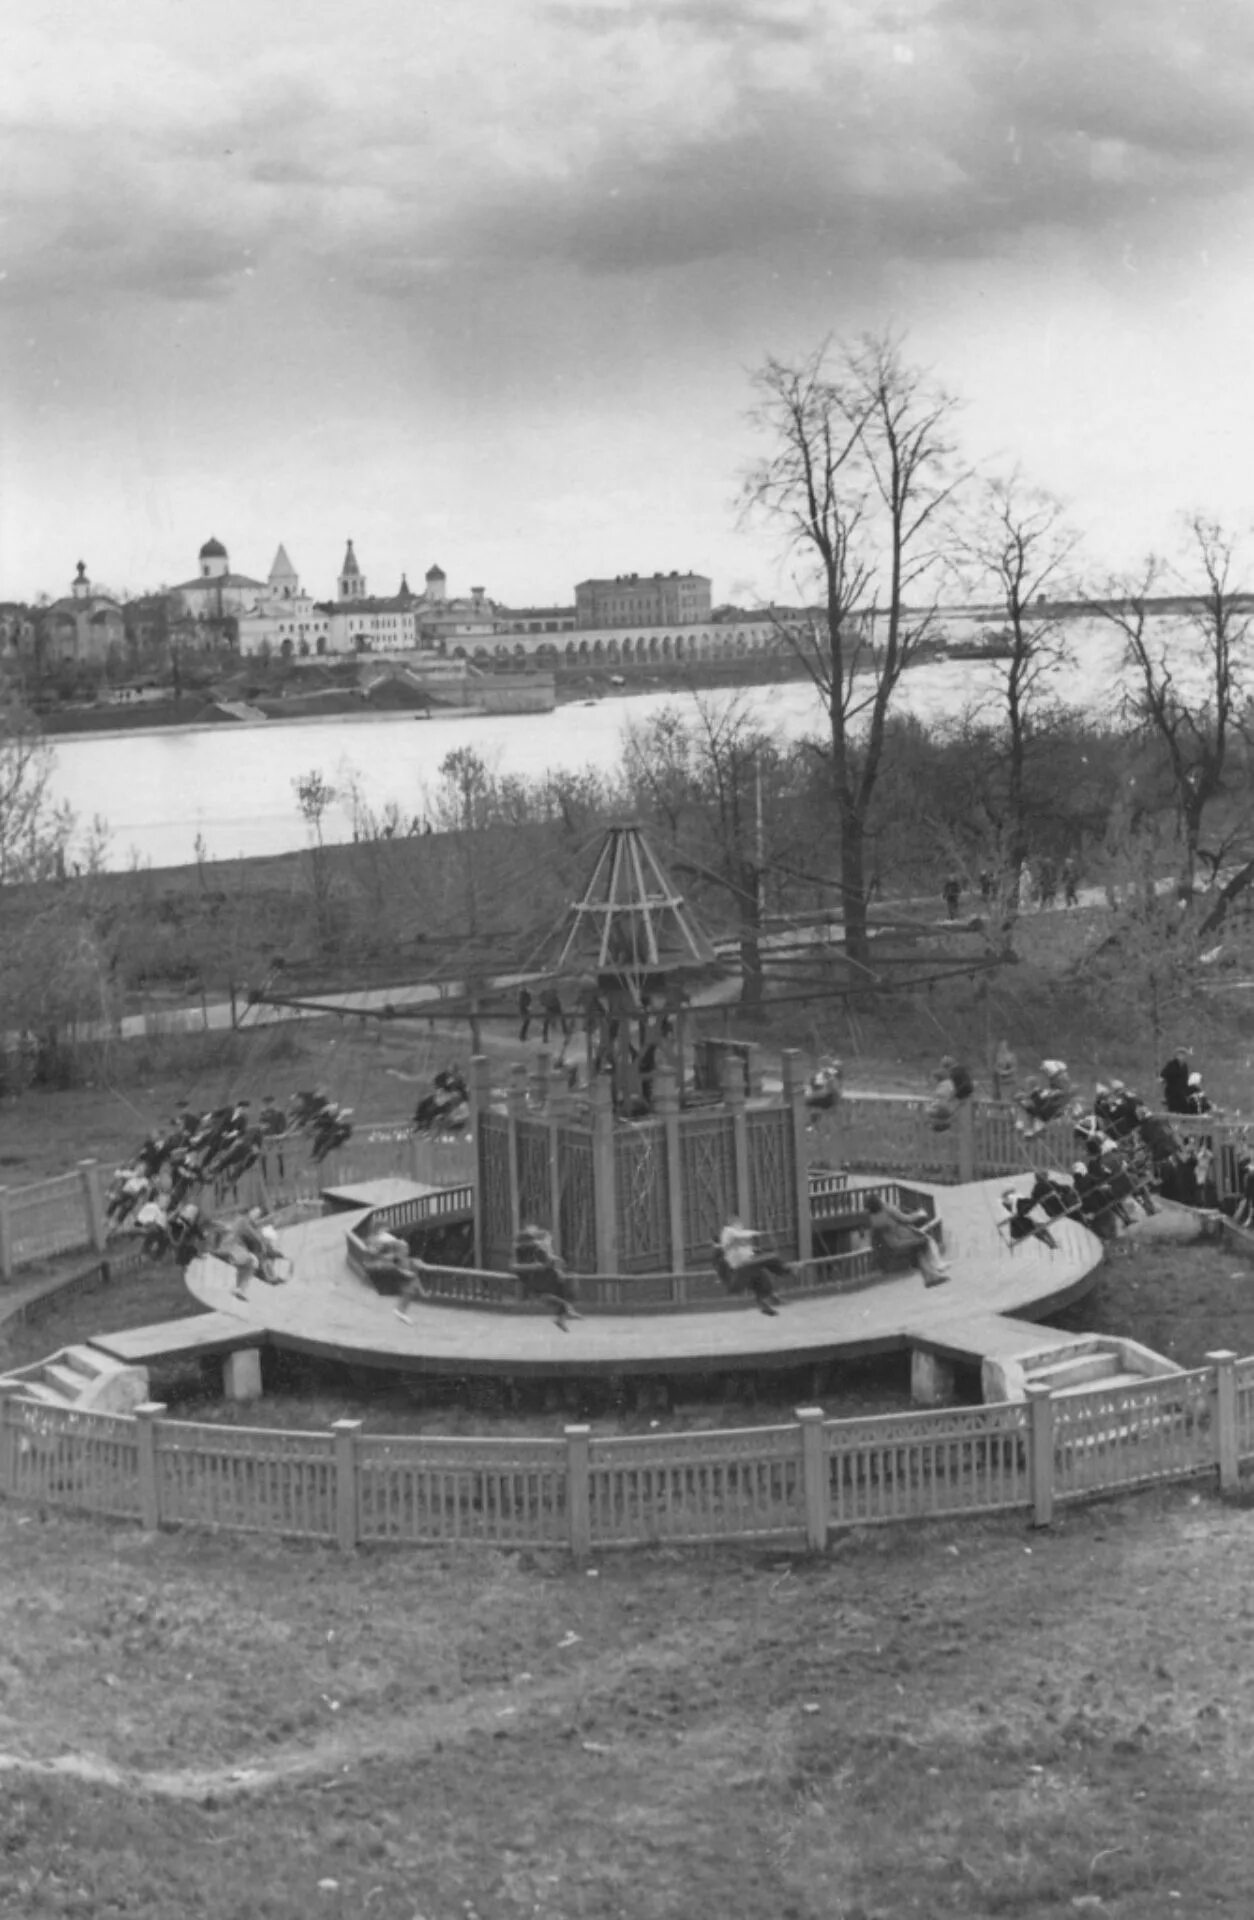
[52,643,1114,868]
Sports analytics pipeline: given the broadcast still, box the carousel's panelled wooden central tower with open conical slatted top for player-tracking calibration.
[472,826,810,1274]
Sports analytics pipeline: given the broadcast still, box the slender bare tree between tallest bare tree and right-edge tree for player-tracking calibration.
[958,470,1079,868]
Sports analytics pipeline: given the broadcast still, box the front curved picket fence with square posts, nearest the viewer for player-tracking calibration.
[0,1352,1254,1559]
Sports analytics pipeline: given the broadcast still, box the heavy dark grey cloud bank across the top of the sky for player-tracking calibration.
[0,0,1254,300]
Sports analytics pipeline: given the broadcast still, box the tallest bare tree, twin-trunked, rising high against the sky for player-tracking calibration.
[743,334,962,968]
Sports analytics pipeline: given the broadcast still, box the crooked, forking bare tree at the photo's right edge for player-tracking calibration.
[1095,515,1254,906]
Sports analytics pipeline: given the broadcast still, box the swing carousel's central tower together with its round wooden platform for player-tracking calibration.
[85,826,1100,1398]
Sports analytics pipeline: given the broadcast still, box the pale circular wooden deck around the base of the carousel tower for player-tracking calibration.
[129,1179,1102,1377]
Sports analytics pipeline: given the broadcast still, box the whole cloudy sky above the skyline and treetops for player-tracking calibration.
[0,0,1254,605]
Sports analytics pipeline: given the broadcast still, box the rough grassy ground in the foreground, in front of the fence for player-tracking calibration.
[0,1490,1254,1920]
